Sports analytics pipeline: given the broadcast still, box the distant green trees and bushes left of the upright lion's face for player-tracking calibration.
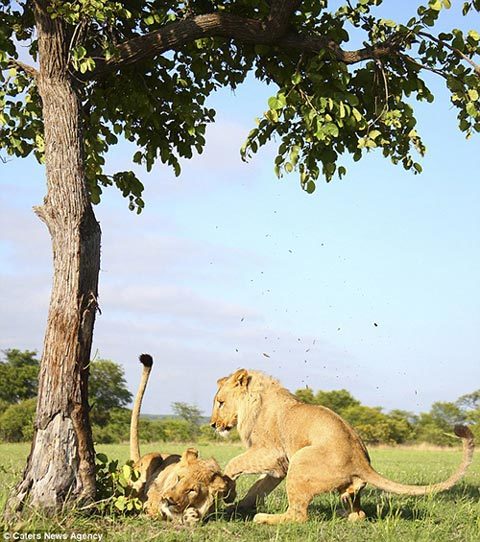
[0,349,230,443]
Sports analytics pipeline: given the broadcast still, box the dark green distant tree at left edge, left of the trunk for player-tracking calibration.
[0,348,40,403]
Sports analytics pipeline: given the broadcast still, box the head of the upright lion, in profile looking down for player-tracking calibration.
[210,369,251,436]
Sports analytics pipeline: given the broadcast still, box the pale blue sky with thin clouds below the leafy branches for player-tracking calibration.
[0,2,480,413]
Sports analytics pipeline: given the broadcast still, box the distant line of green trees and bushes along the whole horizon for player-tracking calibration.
[0,349,480,446]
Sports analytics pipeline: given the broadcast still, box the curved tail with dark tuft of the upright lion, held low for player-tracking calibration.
[362,425,475,495]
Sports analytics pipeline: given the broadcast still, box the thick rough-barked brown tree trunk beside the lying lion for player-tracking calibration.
[7,4,100,514]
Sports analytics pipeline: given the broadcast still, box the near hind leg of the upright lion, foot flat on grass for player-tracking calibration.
[253,446,350,525]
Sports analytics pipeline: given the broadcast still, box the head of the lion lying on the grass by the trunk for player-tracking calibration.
[155,448,235,522]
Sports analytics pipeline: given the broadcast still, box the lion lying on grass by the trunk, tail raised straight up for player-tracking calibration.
[130,354,235,523]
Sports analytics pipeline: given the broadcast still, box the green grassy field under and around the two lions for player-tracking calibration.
[0,444,480,542]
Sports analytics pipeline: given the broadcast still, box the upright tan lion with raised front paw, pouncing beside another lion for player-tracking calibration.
[211,369,474,524]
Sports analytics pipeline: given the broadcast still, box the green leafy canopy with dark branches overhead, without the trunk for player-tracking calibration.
[0,0,480,206]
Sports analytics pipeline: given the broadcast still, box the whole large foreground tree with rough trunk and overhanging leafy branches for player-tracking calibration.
[0,0,480,512]
